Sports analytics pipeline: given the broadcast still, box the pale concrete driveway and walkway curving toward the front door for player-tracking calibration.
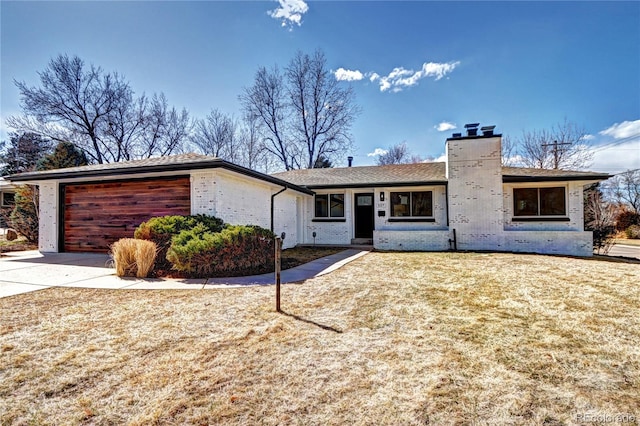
[0,249,368,297]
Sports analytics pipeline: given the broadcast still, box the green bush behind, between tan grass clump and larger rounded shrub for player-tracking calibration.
[134,214,224,271]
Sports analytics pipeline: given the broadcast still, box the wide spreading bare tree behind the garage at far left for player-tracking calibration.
[7,55,188,163]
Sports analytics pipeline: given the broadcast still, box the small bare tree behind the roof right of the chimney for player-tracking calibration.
[515,119,593,170]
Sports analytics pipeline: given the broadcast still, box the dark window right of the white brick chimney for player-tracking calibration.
[513,186,567,216]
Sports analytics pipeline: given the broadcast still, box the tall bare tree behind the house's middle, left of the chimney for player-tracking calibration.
[240,51,359,170]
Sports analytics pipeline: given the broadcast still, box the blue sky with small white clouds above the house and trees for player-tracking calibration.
[0,0,640,173]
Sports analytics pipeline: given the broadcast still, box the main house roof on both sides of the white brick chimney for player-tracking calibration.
[272,163,611,189]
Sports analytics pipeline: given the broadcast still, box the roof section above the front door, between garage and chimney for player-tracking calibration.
[272,163,447,189]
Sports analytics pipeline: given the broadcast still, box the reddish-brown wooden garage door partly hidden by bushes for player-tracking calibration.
[63,177,191,252]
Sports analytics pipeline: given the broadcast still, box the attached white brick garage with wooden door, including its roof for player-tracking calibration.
[9,153,313,253]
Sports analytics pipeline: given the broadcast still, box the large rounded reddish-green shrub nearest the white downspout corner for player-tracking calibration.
[167,224,275,277]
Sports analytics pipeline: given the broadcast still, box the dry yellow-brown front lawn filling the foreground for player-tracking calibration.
[0,253,640,425]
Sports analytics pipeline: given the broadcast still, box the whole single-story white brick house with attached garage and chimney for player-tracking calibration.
[8,125,610,256]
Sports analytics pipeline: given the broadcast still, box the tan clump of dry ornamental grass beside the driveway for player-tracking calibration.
[111,238,157,278]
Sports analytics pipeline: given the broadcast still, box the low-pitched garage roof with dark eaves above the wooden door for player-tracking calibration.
[6,153,313,194]
